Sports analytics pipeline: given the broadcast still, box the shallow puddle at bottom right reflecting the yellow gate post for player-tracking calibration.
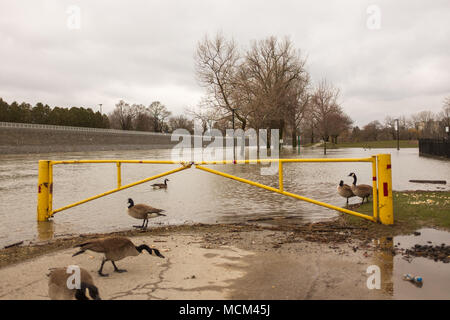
[375,228,450,299]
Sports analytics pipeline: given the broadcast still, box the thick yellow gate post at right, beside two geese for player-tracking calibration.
[377,154,394,224]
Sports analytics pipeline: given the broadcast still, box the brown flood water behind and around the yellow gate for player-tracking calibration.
[0,149,450,247]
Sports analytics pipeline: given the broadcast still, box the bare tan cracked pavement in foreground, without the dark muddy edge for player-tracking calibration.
[0,229,390,300]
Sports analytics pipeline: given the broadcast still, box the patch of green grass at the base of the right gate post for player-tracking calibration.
[342,191,450,235]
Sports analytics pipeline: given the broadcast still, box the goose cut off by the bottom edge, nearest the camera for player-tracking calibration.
[48,268,101,300]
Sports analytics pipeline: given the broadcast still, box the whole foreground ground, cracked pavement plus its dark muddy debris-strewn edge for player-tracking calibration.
[0,220,446,299]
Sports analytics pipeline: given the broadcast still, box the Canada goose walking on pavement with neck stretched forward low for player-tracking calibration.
[72,237,164,277]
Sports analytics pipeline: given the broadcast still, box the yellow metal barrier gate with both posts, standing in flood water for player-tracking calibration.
[37,154,394,224]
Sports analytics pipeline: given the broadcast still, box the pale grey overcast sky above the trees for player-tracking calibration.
[0,0,450,125]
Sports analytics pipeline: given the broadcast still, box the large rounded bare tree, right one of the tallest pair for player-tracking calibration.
[240,37,309,129]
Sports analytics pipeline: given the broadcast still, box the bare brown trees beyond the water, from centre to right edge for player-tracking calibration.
[193,33,450,147]
